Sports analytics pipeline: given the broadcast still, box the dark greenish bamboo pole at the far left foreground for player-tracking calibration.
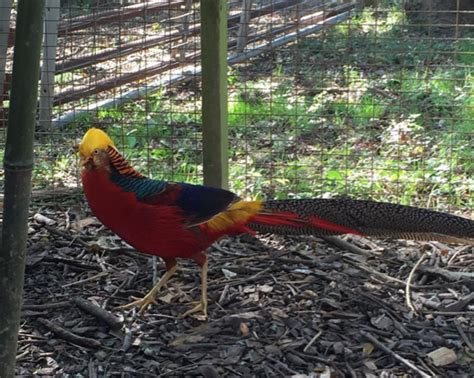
[0,0,44,377]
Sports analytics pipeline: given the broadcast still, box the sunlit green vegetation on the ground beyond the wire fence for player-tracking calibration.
[17,3,474,208]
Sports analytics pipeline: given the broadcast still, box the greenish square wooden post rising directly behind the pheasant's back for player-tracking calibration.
[201,0,229,188]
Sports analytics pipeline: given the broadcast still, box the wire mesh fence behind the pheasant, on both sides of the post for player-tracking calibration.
[0,0,474,209]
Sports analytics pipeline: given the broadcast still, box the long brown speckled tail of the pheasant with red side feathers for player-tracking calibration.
[247,199,474,244]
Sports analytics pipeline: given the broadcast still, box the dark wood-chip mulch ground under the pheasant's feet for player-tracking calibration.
[17,201,474,377]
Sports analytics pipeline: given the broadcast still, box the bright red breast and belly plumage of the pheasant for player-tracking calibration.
[82,170,209,258]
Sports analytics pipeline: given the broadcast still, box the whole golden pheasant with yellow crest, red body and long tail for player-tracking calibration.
[79,128,474,317]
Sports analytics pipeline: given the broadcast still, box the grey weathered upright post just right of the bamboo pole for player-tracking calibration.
[39,0,60,131]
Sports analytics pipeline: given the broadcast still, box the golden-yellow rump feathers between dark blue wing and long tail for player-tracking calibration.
[206,201,263,232]
